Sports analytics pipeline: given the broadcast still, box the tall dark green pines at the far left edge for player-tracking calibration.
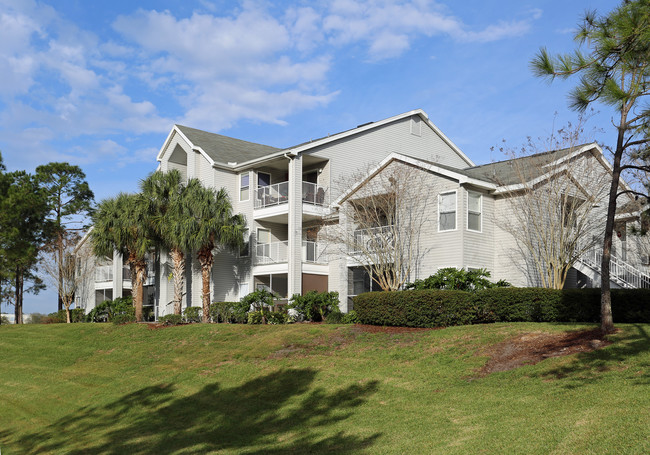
[0,155,94,324]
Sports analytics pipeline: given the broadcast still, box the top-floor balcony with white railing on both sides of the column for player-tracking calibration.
[254,182,329,223]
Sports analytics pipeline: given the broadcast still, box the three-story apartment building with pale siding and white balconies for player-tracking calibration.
[77,110,650,317]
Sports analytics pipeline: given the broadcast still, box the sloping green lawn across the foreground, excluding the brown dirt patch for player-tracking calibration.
[0,323,650,455]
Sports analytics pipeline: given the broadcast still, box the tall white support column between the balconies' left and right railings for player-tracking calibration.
[287,155,302,297]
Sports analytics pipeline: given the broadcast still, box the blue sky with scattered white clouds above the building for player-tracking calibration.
[0,0,618,313]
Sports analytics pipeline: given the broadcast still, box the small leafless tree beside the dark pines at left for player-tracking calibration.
[41,232,95,323]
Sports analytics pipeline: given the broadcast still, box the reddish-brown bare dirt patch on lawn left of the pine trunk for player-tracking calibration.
[478,329,612,376]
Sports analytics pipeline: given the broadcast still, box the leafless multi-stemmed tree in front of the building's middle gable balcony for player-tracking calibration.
[321,160,431,291]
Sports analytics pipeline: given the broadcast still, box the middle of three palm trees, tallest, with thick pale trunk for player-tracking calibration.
[140,169,192,314]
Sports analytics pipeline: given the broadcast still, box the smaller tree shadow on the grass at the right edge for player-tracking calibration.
[537,324,650,389]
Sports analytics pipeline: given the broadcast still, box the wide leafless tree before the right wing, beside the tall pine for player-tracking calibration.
[495,124,611,289]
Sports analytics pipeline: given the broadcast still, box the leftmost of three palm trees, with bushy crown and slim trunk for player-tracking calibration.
[90,193,155,322]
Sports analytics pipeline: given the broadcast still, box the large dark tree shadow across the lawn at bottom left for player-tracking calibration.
[10,369,380,454]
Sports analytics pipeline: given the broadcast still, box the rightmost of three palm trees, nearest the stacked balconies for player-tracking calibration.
[186,179,246,322]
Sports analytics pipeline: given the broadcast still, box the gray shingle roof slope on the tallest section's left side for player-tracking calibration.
[176,125,280,164]
